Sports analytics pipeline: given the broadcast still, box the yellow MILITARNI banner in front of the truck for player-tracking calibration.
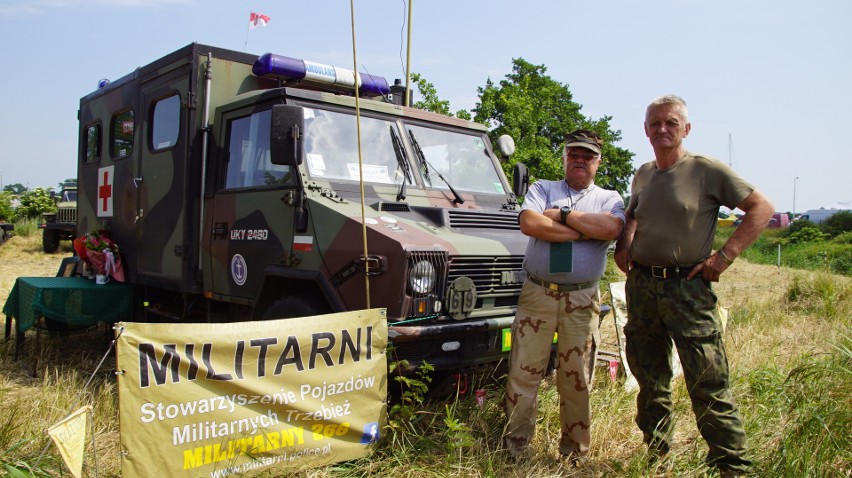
[116,309,387,478]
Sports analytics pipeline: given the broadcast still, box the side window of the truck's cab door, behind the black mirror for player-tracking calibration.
[225,110,295,189]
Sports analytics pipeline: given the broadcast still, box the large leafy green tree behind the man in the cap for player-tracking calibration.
[473,58,633,194]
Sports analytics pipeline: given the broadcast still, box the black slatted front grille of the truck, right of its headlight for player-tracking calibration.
[448,256,524,298]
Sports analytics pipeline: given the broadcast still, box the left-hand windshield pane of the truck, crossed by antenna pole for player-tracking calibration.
[304,108,411,184]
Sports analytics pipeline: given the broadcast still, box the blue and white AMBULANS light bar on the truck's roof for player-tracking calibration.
[251,53,390,96]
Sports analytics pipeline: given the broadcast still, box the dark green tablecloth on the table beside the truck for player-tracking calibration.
[3,277,131,333]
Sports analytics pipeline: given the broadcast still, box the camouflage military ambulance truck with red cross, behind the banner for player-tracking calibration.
[78,44,526,370]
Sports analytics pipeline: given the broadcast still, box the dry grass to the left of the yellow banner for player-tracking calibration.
[0,234,119,476]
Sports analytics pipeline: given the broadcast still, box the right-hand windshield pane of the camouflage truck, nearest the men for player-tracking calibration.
[406,125,504,194]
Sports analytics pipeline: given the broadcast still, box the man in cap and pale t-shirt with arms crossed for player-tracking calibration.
[503,130,624,466]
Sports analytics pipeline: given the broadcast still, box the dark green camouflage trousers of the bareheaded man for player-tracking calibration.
[624,268,751,471]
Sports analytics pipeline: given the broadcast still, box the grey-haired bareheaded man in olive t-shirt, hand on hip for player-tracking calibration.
[615,95,774,477]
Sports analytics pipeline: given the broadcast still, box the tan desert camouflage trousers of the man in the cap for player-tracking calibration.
[503,281,600,455]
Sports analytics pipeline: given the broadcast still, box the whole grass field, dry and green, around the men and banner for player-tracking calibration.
[0,235,852,477]
